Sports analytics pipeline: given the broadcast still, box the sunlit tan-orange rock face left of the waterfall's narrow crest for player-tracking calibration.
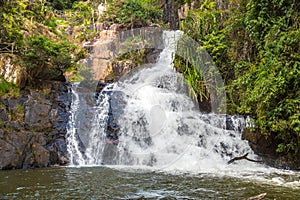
[77,24,162,83]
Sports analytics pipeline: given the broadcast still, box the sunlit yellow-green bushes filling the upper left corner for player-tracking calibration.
[0,0,95,85]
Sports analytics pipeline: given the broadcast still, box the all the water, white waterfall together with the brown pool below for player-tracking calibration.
[0,32,300,199]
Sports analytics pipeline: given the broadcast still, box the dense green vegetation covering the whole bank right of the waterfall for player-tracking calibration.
[177,0,300,157]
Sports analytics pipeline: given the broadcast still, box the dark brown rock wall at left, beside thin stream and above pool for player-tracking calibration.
[0,82,71,169]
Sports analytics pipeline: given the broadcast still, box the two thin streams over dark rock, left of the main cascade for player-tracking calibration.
[67,83,110,166]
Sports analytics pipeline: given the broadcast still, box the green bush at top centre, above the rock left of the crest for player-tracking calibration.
[104,0,162,28]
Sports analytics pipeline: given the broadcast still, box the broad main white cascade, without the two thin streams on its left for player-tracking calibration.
[115,31,255,172]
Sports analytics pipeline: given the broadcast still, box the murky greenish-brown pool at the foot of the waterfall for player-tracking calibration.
[0,166,300,200]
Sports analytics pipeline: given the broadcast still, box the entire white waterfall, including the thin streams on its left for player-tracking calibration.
[67,31,259,172]
